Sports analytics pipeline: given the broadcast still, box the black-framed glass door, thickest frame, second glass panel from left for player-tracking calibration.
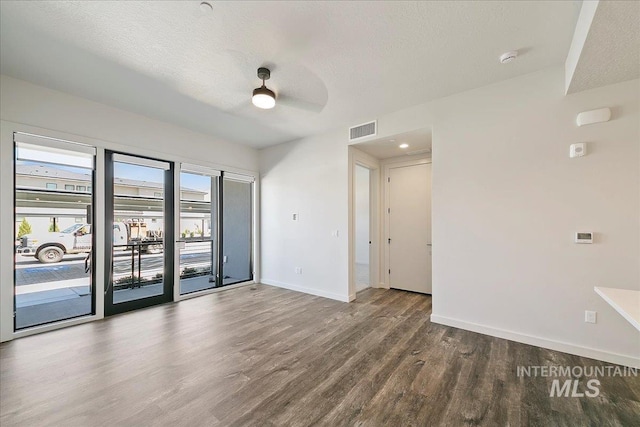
[105,151,174,315]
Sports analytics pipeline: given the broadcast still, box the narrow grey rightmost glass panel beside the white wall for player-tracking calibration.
[221,176,253,286]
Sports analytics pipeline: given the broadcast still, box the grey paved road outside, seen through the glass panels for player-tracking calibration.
[16,252,211,286]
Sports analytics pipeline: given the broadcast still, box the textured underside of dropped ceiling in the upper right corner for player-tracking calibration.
[567,0,640,93]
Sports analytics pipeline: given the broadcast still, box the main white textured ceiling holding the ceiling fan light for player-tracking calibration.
[0,1,580,148]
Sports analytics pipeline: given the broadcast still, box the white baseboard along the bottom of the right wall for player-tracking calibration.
[431,314,640,368]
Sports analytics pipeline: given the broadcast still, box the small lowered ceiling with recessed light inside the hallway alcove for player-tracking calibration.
[353,128,431,160]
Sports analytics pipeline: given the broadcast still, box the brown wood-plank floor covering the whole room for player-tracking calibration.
[0,285,640,427]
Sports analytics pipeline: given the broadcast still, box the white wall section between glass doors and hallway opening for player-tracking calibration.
[260,130,349,301]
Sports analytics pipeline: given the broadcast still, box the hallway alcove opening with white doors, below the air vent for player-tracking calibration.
[349,127,433,300]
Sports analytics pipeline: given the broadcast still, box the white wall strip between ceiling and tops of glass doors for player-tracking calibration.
[0,75,258,172]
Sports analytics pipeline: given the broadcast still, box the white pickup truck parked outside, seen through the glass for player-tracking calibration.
[17,222,129,263]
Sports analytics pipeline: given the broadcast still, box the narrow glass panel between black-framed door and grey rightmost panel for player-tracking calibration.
[178,172,218,295]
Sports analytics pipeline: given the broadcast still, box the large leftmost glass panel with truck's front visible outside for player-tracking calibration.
[14,133,95,330]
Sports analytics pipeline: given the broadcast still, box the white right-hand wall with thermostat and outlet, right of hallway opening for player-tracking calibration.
[433,72,640,365]
